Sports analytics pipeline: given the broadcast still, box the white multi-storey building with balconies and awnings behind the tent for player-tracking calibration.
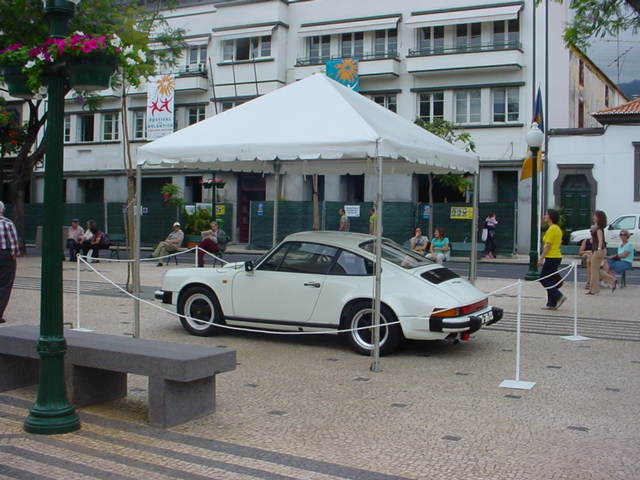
[1,0,624,250]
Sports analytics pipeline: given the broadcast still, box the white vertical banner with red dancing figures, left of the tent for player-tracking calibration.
[147,75,175,140]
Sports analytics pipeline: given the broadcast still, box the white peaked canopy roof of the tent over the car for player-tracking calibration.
[138,74,478,174]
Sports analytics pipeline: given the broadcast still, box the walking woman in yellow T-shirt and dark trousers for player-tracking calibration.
[538,209,567,310]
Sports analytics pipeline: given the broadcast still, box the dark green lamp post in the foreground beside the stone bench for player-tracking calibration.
[24,0,80,434]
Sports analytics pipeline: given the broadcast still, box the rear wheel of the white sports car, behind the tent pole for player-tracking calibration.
[342,300,403,356]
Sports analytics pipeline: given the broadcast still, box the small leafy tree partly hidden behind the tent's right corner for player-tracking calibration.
[415,118,476,237]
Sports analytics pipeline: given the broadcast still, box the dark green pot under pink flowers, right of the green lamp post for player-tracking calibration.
[66,52,117,91]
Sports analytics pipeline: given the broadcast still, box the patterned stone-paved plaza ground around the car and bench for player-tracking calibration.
[0,257,640,480]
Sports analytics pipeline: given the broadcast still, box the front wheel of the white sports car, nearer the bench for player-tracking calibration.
[177,287,224,337]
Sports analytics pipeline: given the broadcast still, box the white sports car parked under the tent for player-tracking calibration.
[156,232,502,355]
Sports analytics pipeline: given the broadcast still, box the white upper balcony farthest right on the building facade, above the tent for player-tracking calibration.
[407,42,523,75]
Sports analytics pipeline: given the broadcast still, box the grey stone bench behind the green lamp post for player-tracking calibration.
[0,325,236,428]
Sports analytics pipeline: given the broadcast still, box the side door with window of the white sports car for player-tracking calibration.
[229,242,337,327]
